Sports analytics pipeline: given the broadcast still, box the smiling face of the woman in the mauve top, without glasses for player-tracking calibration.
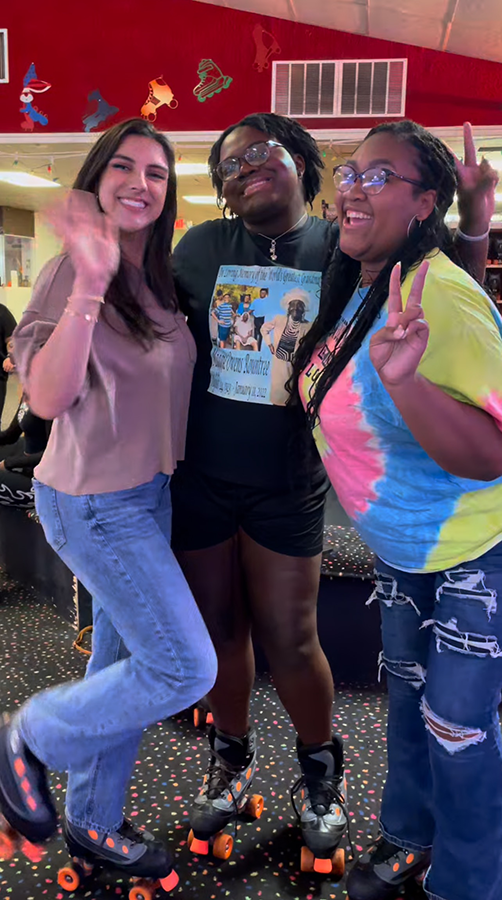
[98,135,169,233]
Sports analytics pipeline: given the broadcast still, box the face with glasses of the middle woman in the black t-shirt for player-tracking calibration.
[220,126,305,223]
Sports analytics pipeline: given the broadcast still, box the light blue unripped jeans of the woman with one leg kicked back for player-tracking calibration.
[18,475,216,831]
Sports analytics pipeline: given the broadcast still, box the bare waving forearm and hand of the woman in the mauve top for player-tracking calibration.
[14,192,120,419]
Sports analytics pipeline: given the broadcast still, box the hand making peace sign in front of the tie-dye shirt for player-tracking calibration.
[370,262,429,386]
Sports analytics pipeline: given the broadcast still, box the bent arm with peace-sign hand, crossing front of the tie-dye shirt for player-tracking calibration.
[370,263,502,481]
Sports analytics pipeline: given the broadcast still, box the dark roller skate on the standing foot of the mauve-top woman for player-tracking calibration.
[58,819,179,900]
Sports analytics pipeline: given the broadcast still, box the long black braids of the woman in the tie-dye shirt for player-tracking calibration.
[288,120,461,428]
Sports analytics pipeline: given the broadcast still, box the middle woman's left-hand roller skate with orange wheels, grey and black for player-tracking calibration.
[188,725,263,859]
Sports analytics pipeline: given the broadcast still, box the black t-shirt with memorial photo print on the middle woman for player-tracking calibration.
[173,217,338,488]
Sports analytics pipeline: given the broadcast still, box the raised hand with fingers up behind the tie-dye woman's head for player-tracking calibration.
[453,122,499,235]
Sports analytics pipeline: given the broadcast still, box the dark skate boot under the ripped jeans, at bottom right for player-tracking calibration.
[347,835,431,900]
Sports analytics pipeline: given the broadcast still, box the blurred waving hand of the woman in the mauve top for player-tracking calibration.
[44,191,120,296]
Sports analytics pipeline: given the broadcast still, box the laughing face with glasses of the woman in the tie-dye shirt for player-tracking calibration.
[335,133,436,265]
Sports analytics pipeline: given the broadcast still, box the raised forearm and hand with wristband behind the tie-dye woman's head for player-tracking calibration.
[454,122,498,284]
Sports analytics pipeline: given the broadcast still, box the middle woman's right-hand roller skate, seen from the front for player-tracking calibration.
[291,735,347,878]
